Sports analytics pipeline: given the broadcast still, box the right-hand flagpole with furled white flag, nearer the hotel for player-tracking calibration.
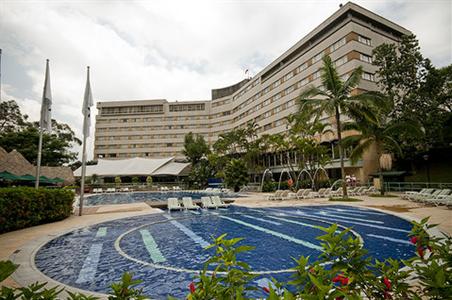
[78,66,92,216]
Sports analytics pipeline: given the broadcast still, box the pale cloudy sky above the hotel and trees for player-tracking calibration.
[0,0,452,159]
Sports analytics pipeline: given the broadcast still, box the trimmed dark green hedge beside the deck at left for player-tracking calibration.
[0,187,74,233]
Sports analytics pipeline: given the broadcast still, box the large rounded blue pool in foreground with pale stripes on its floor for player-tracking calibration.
[35,205,413,299]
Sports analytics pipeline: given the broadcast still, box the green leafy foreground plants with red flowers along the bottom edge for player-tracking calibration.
[0,218,452,300]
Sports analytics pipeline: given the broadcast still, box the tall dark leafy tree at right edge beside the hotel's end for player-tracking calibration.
[374,35,452,158]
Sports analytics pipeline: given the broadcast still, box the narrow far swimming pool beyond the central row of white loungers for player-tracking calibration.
[85,191,239,206]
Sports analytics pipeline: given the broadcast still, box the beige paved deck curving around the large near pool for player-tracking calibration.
[0,193,452,298]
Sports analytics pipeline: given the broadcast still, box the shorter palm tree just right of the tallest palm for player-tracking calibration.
[342,96,422,196]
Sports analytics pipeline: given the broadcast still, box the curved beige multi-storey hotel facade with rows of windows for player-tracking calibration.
[94,2,411,180]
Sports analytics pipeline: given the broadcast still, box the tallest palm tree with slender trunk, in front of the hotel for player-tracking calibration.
[300,55,373,197]
